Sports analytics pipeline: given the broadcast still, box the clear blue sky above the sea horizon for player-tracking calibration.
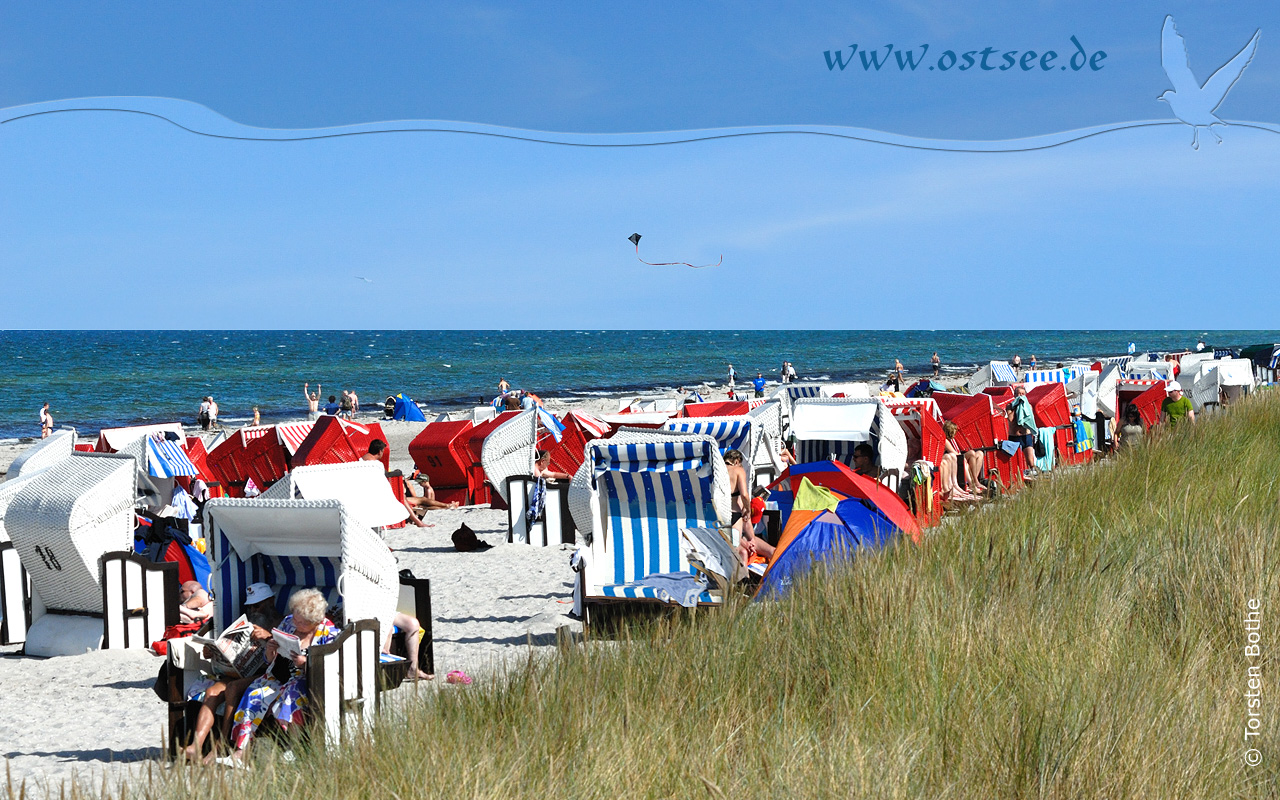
[0,1,1280,329]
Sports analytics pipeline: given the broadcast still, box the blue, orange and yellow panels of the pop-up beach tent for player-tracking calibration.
[755,475,899,599]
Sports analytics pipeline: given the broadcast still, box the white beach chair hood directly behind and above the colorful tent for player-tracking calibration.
[791,397,906,470]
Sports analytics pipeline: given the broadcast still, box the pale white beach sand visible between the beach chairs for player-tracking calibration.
[0,376,988,794]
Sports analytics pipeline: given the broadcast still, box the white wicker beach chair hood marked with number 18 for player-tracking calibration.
[4,453,137,614]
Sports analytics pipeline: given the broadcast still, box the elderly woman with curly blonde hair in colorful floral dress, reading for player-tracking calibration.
[219,589,339,765]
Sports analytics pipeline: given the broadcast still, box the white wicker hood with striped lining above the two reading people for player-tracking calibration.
[205,499,399,631]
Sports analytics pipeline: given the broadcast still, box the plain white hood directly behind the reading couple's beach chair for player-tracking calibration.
[259,461,408,527]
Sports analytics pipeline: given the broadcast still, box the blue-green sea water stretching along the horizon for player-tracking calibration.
[0,330,1280,438]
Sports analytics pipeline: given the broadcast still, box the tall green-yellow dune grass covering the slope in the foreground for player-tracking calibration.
[77,394,1280,800]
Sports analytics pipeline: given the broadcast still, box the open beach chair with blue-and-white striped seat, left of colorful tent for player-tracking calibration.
[570,430,730,616]
